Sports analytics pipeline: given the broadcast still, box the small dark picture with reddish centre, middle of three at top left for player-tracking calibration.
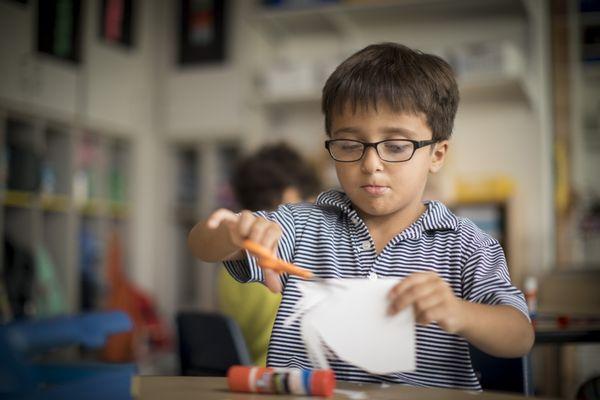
[98,0,135,48]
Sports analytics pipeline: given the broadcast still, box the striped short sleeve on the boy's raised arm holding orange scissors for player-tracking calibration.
[223,205,296,287]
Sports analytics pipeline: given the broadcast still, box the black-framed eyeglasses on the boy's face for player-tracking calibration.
[325,139,437,162]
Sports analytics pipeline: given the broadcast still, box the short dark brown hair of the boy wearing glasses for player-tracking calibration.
[321,43,459,140]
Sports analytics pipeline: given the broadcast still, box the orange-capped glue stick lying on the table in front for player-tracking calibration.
[227,365,335,397]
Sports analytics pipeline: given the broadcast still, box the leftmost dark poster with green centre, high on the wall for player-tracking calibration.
[37,0,81,64]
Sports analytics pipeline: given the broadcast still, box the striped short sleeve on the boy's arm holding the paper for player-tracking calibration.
[462,242,529,318]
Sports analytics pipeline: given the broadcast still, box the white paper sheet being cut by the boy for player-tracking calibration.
[299,279,416,374]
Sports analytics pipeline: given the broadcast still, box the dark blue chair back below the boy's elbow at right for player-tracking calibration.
[469,346,533,396]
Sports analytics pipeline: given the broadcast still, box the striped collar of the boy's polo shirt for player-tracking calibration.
[315,190,458,238]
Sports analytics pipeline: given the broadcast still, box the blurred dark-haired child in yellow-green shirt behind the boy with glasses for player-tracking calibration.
[218,143,320,366]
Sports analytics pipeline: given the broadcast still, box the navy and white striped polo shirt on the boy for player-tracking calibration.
[225,191,528,390]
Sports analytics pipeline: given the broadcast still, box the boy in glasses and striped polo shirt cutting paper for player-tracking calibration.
[189,43,533,389]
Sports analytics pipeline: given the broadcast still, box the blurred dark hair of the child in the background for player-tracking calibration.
[231,143,321,211]
